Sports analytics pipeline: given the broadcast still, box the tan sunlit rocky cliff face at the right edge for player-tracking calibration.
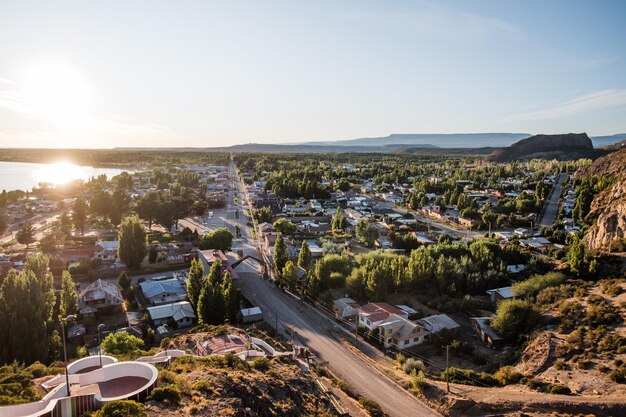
[576,149,626,249]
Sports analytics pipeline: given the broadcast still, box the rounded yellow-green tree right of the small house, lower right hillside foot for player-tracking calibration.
[491,298,541,342]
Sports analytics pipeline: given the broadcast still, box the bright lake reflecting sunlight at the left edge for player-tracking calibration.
[0,162,133,191]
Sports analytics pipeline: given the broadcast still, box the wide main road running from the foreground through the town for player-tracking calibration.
[228,158,440,417]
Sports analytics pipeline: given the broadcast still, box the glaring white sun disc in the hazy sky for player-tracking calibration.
[22,62,91,122]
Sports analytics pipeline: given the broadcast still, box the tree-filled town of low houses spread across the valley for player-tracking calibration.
[0,144,626,415]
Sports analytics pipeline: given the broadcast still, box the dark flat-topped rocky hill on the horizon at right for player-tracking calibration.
[486,133,595,162]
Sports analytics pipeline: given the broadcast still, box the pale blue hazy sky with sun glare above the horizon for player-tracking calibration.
[0,0,626,148]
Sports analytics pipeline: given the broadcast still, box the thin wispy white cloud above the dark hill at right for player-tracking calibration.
[502,89,626,122]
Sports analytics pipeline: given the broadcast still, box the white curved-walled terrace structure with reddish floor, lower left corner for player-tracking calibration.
[0,357,159,417]
